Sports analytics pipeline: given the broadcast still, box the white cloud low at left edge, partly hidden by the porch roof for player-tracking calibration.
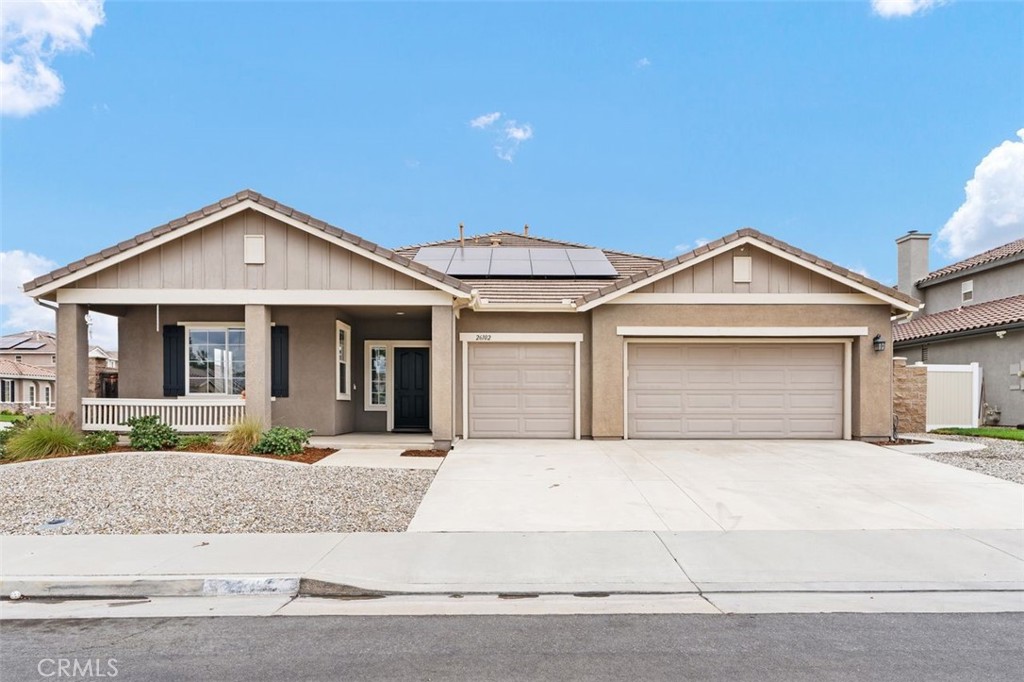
[0,251,118,350]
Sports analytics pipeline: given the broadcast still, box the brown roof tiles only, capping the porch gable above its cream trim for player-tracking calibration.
[25,189,469,294]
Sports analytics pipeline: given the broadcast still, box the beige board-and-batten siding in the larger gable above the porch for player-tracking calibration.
[73,211,430,291]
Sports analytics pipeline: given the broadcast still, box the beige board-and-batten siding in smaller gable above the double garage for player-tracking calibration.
[637,246,854,294]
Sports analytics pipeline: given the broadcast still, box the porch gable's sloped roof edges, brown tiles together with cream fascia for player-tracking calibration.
[24,189,470,297]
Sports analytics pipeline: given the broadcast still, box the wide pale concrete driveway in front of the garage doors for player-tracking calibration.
[409,440,1024,531]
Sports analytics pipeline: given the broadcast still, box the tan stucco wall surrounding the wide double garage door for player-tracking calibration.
[591,305,892,438]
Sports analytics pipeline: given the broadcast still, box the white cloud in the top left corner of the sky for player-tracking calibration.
[0,0,104,116]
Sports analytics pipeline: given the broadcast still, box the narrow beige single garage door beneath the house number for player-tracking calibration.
[468,343,575,438]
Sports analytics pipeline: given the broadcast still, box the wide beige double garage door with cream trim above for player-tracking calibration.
[627,342,843,438]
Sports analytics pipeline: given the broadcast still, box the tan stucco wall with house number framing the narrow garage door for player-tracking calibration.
[455,310,595,436]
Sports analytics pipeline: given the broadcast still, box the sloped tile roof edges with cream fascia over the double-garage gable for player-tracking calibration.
[577,227,921,312]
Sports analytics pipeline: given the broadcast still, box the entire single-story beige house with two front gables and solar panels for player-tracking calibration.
[25,190,918,446]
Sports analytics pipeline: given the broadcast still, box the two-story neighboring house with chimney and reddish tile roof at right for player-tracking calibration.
[893,232,1024,425]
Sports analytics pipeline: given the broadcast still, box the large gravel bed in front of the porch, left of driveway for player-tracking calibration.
[0,453,434,535]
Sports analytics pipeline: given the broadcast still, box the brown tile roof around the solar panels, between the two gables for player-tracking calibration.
[395,231,662,304]
